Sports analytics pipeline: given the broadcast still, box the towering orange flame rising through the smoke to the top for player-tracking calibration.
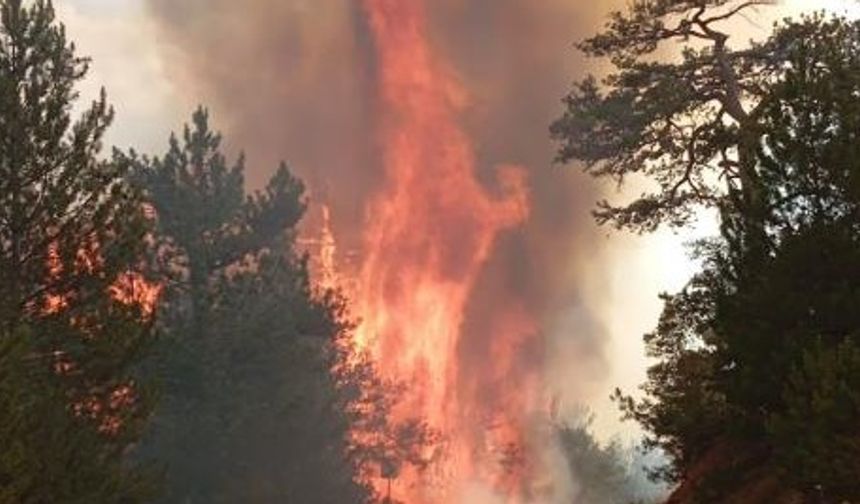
[355,0,538,504]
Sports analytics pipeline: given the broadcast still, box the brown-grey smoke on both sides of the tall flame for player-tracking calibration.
[147,0,610,502]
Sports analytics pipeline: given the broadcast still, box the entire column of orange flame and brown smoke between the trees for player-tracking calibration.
[144,1,620,503]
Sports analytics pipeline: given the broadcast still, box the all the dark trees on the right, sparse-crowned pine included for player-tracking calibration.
[552,0,860,503]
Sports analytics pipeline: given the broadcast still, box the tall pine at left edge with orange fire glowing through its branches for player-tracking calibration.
[0,0,157,503]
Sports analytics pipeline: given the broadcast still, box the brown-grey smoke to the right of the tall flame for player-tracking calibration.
[424,0,624,426]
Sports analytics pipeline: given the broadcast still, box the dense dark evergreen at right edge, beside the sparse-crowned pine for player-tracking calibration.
[580,10,860,503]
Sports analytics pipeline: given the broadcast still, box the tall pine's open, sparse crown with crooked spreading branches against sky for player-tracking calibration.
[551,0,797,256]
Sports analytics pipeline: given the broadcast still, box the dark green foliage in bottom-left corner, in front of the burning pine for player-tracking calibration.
[0,328,157,504]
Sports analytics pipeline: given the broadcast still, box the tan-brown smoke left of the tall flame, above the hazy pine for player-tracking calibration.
[147,0,381,254]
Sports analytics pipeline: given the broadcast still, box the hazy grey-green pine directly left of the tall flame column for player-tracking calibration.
[129,109,367,503]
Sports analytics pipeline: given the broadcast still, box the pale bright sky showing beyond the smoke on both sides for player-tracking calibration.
[55,0,860,436]
